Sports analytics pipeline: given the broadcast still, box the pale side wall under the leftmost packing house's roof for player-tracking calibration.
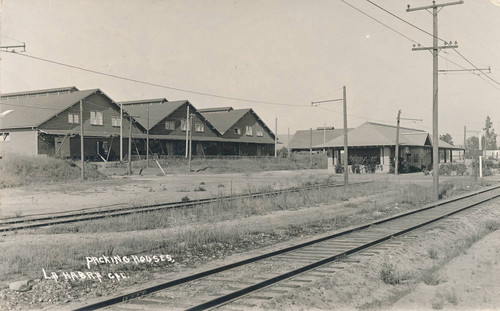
[0,129,38,156]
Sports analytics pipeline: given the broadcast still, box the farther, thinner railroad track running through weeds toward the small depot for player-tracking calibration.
[0,182,367,232]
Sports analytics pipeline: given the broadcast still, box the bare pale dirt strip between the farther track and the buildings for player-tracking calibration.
[0,169,484,219]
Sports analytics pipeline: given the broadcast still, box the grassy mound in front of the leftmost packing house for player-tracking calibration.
[0,154,105,188]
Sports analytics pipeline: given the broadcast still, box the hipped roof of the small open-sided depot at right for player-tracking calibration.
[318,122,461,149]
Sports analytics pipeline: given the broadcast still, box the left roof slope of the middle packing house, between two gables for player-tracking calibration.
[122,98,189,130]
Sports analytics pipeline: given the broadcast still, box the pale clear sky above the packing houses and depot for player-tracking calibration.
[0,0,500,144]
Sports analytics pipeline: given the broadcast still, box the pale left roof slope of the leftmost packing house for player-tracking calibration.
[0,89,98,129]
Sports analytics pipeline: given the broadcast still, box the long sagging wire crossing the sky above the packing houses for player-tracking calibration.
[1,51,309,107]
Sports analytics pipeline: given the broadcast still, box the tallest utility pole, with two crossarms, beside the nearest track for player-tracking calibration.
[406,0,464,201]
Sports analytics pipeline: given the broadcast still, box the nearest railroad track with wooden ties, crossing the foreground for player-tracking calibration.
[71,186,500,310]
